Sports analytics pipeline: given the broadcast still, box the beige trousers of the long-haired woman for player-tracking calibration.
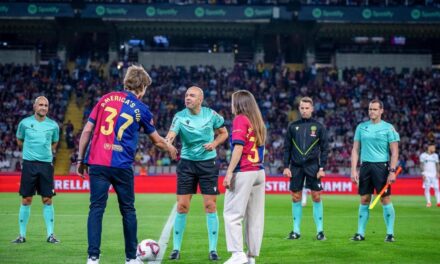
[223,170,265,256]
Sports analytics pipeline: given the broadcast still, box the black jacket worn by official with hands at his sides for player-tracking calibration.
[284,118,328,168]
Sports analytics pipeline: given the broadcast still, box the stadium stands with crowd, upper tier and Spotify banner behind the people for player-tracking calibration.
[0,0,440,176]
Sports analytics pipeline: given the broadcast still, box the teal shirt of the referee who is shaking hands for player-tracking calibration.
[170,107,225,161]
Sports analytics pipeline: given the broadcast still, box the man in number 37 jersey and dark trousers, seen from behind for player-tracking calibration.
[77,65,177,263]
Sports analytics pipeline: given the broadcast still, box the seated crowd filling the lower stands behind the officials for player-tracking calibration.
[0,59,440,175]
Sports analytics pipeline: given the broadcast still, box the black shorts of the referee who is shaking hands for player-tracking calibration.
[177,159,219,195]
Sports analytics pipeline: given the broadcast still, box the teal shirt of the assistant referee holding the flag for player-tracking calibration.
[354,120,400,162]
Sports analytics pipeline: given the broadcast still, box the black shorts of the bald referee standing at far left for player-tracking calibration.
[19,160,55,197]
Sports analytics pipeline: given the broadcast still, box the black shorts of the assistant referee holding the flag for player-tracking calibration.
[358,162,391,197]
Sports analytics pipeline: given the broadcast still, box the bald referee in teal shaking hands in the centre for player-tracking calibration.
[166,86,228,260]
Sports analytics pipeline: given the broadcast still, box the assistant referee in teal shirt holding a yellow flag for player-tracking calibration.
[351,99,400,242]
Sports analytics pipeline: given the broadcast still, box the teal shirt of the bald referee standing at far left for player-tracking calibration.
[16,115,60,162]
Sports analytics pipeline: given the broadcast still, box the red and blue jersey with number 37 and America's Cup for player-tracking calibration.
[85,91,156,168]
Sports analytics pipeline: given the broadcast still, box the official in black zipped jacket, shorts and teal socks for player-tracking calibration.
[283,97,328,240]
